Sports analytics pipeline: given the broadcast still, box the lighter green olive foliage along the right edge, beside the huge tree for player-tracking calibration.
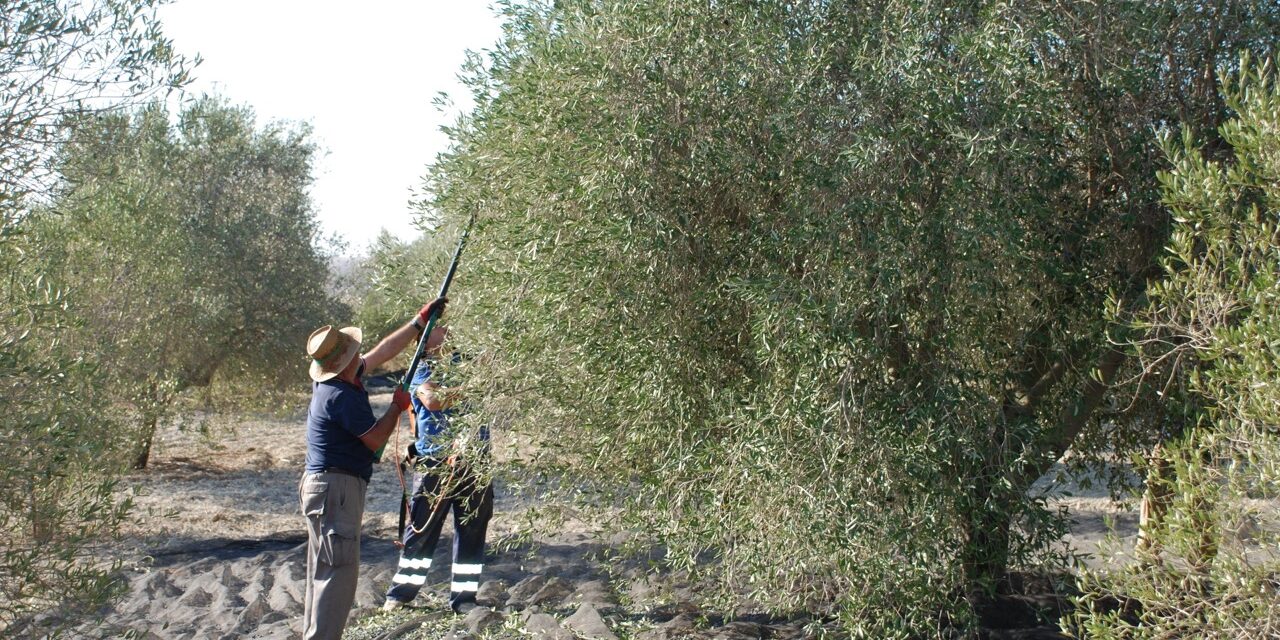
[1074,59,1280,639]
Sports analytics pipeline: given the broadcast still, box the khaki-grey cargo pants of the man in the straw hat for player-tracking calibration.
[298,472,369,640]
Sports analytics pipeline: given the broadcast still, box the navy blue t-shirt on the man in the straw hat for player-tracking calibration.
[306,362,378,480]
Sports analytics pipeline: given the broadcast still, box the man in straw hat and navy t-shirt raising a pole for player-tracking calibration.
[298,298,447,640]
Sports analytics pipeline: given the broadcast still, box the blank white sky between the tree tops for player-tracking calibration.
[159,0,500,253]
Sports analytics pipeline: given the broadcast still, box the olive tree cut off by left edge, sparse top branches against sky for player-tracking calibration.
[0,0,188,629]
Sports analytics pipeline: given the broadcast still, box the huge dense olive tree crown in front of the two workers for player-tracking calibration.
[409,0,1280,637]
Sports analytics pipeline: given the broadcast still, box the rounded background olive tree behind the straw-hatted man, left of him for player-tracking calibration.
[32,97,346,467]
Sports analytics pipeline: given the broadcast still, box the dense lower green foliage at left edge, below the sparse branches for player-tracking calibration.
[0,254,137,637]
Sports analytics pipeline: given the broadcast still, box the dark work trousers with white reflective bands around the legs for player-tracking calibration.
[387,462,493,609]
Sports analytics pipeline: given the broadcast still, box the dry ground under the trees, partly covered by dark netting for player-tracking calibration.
[62,394,1135,640]
